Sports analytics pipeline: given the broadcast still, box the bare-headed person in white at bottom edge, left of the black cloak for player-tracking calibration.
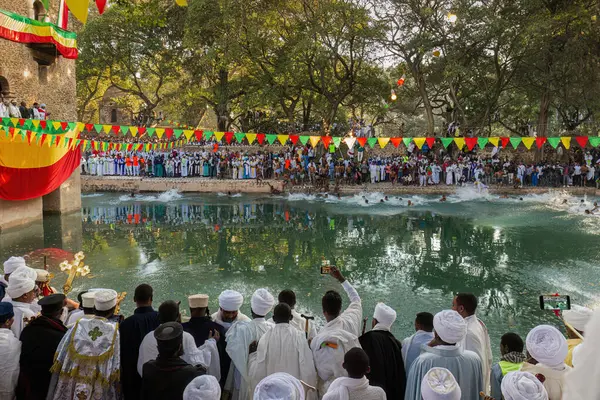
[323,348,386,400]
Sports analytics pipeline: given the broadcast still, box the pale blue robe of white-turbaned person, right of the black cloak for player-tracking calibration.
[404,345,483,400]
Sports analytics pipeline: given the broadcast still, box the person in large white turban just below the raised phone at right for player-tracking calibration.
[521,325,572,400]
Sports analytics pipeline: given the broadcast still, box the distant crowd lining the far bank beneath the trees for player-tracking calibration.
[81,145,600,187]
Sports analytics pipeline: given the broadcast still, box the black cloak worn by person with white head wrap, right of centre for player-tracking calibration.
[358,331,406,400]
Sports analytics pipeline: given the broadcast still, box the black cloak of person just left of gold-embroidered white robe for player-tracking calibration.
[16,315,67,400]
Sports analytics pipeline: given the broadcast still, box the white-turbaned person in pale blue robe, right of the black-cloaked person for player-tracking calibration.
[404,310,483,400]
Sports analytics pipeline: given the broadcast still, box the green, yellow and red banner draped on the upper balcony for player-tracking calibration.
[0,9,78,58]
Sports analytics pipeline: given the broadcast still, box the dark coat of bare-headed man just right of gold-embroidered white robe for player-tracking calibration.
[119,307,160,400]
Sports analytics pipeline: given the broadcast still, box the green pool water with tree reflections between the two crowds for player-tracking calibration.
[0,194,600,352]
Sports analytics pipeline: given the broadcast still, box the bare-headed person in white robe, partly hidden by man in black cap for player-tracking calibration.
[137,300,221,379]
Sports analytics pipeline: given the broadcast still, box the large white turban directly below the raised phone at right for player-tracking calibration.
[525,325,569,367]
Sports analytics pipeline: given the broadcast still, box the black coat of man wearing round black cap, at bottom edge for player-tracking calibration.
[141,357,206,400]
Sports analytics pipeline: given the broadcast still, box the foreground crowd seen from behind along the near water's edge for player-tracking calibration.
[0,257,600,400]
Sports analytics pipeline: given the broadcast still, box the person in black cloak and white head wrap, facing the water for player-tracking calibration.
[358,303,406,399]
